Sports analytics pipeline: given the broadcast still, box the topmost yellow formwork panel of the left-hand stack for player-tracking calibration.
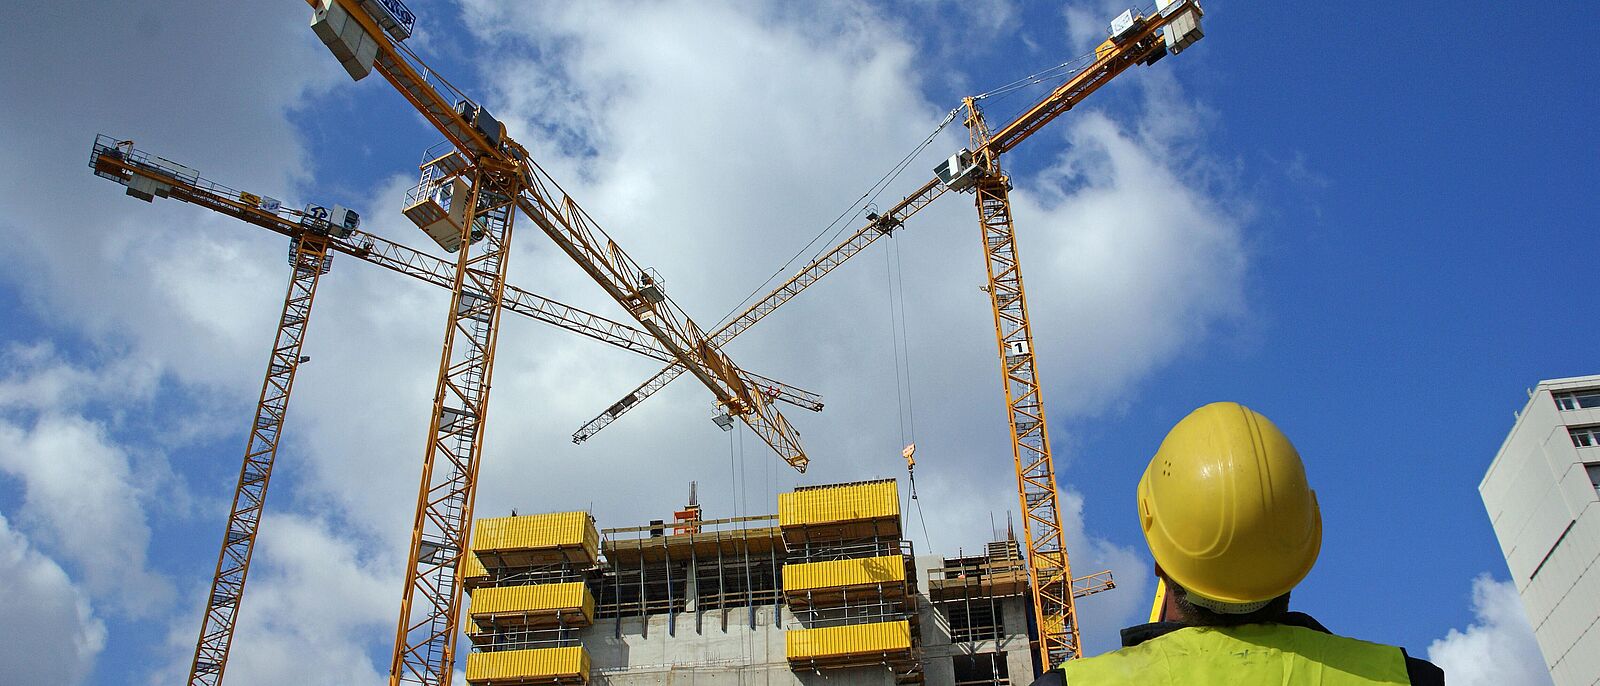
[472,512,600,564]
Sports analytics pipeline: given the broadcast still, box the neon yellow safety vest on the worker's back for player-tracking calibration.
[1061,624,1411,686]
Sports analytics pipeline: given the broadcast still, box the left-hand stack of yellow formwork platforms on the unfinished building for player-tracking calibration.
[461,512,600,686]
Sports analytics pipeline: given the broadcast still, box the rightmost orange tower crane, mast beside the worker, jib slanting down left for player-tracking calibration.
[573,0,1203,668]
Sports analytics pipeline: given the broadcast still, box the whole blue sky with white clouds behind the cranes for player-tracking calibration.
[0,0,1600,684]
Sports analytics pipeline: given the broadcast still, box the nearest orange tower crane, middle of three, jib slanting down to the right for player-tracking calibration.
[296,0,810,686]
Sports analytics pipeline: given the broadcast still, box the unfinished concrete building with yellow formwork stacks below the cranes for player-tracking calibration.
[462,480,1109,686]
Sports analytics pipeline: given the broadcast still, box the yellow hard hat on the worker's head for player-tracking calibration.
[1139,403,1322,612]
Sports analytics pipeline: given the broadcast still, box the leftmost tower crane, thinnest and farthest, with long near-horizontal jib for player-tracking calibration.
[90,136,822,686]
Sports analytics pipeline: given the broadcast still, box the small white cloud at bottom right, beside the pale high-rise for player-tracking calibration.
[1427,574,1552,686]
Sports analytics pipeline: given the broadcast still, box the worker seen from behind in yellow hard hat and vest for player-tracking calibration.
[1034,403,1445,686]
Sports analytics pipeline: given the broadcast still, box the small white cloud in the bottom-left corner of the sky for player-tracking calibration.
[0,515,106,686]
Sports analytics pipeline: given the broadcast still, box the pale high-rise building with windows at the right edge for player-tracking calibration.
[1478,376,1600,686]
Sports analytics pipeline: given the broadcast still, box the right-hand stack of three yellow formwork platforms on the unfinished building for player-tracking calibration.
[778,480,923,683]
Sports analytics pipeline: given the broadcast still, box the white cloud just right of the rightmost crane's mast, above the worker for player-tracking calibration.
[1014,110,1246,416]
